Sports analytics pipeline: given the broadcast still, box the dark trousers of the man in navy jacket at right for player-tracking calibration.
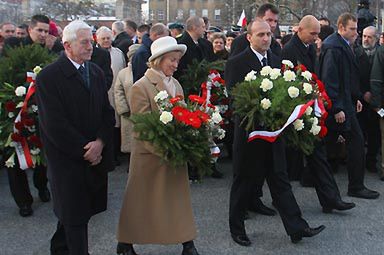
[325,114,365,191]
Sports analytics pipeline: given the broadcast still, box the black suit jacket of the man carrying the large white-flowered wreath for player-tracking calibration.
[225,46,285,176]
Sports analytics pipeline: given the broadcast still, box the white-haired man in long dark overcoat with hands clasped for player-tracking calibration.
[36,20,115,255]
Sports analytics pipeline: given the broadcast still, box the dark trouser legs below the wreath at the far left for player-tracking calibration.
[7,166,48,207]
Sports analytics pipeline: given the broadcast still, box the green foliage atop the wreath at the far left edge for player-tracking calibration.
[0,44,57,87]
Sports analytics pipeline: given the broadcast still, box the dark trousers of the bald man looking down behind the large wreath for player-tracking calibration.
[303,141,341,207]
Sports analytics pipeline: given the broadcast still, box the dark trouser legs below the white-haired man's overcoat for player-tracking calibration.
[51,221,88,255]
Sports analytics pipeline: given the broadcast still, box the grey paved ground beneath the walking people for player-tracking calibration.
[0,155,384,255]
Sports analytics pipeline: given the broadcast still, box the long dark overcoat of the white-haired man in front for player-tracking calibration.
[36,54,115,225]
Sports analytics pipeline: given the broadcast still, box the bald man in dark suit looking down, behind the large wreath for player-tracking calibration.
[282,15,355,212]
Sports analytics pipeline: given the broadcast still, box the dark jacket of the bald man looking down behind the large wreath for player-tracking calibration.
[281,34,316,72]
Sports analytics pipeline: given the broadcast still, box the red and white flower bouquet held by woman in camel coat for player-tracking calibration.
[130,90,225,176]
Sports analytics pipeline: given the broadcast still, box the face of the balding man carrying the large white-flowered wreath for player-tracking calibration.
[247,22,272,54]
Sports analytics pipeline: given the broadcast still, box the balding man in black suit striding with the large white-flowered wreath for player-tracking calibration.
[225,19,325,246]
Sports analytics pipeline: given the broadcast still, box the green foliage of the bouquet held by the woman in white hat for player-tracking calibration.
[130,112,211,176]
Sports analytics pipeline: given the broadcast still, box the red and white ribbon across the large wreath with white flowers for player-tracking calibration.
[248,100,315,143]
